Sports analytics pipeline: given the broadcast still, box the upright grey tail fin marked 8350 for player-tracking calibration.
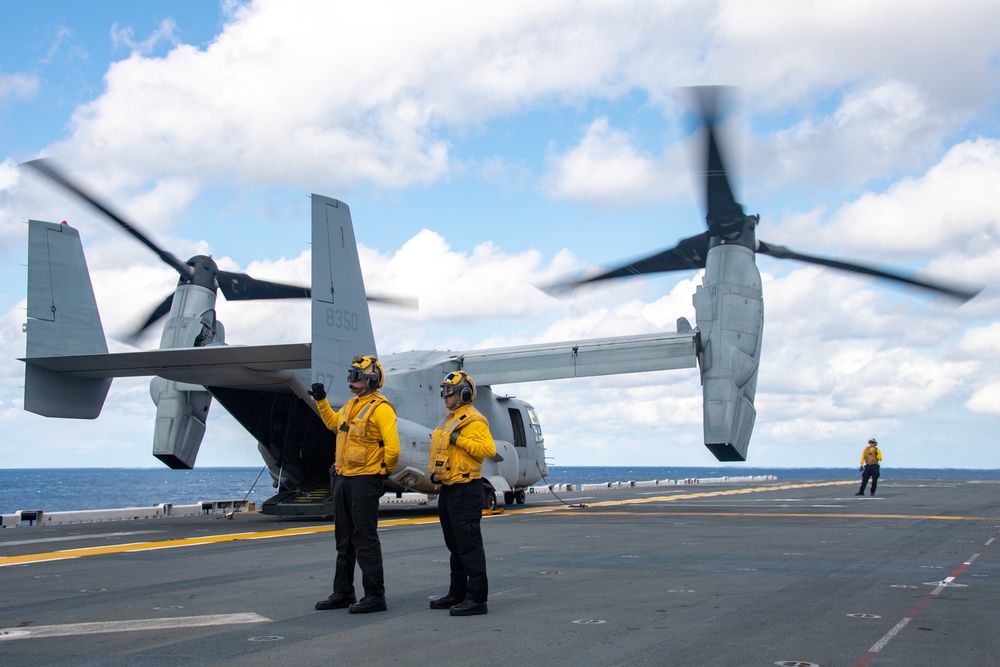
[312,194,377,405]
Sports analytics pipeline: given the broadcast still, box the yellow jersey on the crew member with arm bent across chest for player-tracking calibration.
[428,403,497,486]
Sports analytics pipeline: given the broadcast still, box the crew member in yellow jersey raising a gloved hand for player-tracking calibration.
[309,356,399,614]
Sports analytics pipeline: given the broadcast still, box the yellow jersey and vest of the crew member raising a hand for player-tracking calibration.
[316,391,399,477]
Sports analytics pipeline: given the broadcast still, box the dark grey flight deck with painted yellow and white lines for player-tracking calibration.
[0,479,1000,667]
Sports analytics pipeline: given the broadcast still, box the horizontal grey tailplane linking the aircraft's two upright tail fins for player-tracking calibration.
[21,343,312,387]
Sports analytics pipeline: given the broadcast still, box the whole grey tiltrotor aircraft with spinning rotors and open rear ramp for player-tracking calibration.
[23,88,978,516]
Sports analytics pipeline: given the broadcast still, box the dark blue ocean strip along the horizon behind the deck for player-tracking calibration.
[0,466,1000,514]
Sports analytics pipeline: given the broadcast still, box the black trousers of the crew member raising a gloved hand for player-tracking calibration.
[333,475,385,595]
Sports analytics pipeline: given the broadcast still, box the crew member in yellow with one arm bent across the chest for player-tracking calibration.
[429,371,497,616]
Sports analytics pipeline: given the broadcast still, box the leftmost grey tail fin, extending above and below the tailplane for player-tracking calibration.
[24,220,111,419]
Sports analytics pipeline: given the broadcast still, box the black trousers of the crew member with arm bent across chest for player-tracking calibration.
[438,479,489,602]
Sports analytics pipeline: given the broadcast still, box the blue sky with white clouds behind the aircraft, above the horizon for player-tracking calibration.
[0,0,1000,472]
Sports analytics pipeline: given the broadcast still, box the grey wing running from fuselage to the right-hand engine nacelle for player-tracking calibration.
[461,329,698,385]
